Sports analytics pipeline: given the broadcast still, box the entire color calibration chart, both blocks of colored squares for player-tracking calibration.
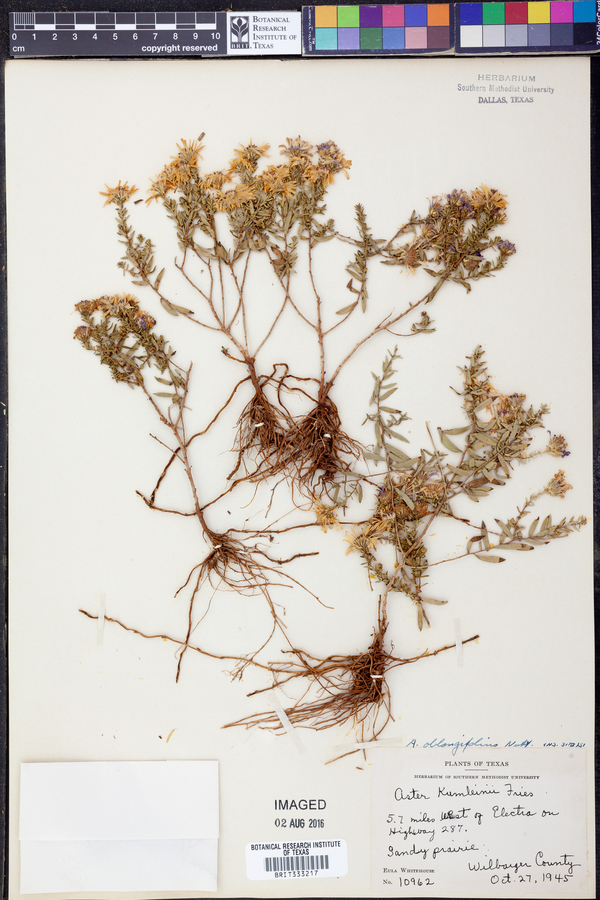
[302,0,600,56]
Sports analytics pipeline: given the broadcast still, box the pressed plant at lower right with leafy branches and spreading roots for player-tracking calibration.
[223,348,586,740]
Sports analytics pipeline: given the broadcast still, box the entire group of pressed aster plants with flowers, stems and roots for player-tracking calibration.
[75,135,584,752]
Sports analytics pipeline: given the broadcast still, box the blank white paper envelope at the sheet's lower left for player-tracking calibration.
[19,760,219,894]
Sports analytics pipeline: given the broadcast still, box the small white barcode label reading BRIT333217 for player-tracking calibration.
[246,840,348,881]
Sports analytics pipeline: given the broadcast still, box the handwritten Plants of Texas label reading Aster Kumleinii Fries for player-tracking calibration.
[372,747,593,897]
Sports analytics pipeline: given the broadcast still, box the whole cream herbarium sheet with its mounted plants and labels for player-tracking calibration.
[6,58,594,898]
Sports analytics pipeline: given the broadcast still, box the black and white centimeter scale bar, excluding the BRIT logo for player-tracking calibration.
[9,12,227,58]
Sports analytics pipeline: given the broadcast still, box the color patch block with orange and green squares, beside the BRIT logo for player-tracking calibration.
[304,3,454,56]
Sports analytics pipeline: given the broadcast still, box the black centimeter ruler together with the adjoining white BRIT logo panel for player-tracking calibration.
[9,11,301,58]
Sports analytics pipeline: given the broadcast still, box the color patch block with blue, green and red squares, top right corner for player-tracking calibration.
[456,0,597,52]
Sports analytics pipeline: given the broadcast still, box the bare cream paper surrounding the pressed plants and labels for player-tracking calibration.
[6,58,594,900]
